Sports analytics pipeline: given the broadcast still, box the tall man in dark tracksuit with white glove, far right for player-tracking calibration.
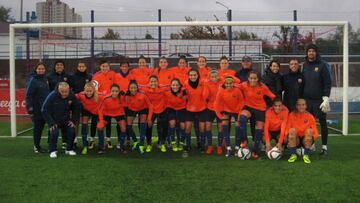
[302,44,331,155]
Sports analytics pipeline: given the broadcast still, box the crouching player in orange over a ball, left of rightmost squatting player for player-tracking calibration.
[264,98,289,152]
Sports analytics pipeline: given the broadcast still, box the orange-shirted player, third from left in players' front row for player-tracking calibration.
[125,80,153,154]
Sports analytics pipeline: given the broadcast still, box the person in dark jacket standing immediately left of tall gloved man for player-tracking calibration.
[282,59,304,111]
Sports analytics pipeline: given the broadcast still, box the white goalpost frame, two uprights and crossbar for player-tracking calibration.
[9,21,349,137]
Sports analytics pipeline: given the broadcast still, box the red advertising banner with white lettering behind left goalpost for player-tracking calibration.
[0,88,27,115]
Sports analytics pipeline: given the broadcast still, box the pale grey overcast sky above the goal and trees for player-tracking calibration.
[0,0,360,28]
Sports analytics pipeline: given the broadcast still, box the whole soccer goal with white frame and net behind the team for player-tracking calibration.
[9,21,350,137]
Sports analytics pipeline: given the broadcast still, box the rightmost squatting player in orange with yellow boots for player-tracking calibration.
[285,99,319,164]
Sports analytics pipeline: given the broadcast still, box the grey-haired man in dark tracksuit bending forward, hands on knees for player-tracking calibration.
[41,82,81,158]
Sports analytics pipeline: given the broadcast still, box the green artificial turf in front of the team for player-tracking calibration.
[0,136,360,202]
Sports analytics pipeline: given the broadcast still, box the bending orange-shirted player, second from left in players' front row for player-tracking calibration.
[98,84,127,154]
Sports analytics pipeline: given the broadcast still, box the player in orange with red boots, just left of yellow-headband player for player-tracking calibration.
[205,70,223,155]
